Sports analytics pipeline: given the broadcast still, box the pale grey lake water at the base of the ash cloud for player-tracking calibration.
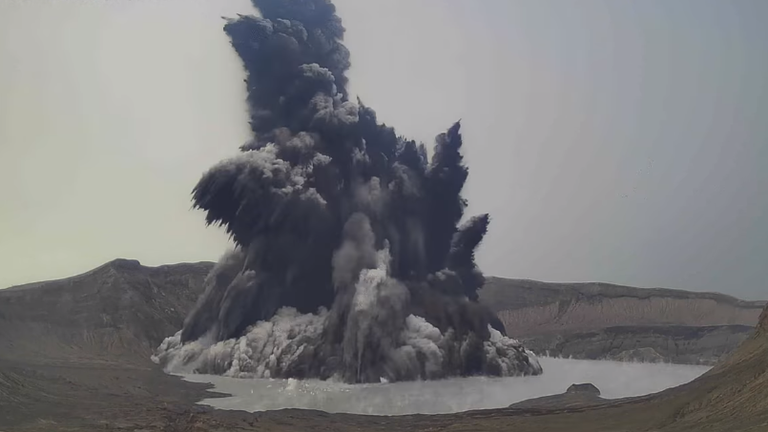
[178,357,709,415]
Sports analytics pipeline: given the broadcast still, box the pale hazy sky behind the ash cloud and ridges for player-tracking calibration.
[0,0,768,299]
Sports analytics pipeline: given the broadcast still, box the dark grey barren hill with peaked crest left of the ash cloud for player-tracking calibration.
[0,259,211,363]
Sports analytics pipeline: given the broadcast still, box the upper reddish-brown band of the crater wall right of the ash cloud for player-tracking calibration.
[480,278,765,339]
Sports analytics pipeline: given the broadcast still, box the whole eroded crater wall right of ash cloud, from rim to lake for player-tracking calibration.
[480,278,765,365]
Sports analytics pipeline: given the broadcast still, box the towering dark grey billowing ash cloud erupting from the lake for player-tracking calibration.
[154,0,541,382]
